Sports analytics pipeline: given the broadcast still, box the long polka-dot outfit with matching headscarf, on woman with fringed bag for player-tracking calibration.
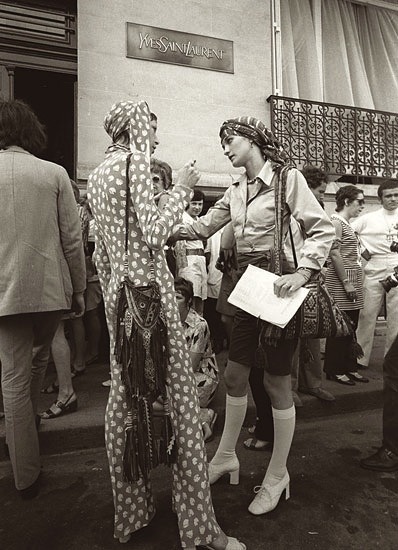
[88,102,220,547]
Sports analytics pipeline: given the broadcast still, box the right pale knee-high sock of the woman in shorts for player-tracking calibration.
[263,405,296,485]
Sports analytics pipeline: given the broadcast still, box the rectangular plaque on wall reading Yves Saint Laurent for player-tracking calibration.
[127,23,234,73]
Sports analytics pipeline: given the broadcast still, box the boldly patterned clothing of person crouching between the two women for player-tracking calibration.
[184,308,218,407]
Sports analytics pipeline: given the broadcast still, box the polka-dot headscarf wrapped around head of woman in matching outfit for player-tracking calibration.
[104,101,151,159]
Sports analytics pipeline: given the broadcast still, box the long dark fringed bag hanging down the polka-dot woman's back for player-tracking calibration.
[115,155,176,481]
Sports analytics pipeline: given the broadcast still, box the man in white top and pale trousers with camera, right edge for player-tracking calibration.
[352,180,398,367]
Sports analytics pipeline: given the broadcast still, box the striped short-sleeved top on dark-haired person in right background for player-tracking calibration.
[326,214,364,310]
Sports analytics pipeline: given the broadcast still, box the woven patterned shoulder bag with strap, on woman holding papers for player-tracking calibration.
[260,166,355,345]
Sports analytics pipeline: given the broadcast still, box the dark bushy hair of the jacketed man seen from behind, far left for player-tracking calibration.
[0,99,47,155]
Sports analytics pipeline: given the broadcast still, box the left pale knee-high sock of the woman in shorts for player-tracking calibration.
[211,394,247,464]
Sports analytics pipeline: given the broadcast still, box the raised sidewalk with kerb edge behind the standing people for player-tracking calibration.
[0,321,385,461]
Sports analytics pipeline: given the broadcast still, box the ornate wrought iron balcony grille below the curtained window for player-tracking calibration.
[268,95,398,178]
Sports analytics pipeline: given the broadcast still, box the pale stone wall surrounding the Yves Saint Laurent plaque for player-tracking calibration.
[77,0,272,182]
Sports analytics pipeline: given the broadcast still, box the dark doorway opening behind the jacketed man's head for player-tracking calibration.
[14,67,76,178]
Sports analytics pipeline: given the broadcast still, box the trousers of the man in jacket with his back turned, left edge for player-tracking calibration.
[0,311,62,490]
